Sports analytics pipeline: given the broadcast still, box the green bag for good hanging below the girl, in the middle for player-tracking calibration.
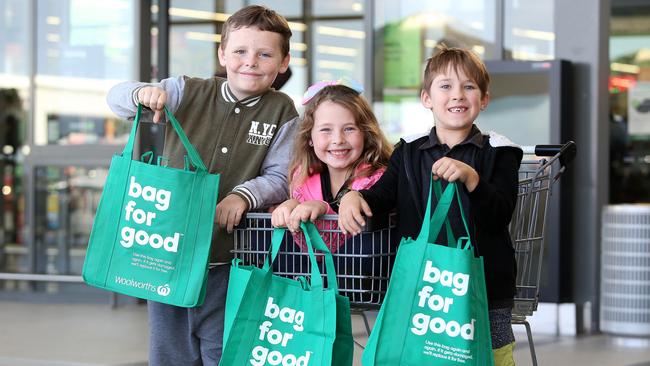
[219,223,353,366]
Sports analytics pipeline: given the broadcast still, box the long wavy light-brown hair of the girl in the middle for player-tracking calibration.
[289,85,393,191]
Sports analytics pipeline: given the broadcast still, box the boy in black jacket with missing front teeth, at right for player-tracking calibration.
[339,46,523,366]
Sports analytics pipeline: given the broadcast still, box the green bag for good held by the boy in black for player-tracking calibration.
[361,182,494,366]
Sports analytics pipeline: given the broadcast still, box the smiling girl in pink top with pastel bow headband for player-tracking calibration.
[271,78,392,252]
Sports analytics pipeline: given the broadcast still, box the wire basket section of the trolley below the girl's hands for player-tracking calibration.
[233,213,399,347]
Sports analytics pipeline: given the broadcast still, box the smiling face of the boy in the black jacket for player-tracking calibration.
[420,67,489,136]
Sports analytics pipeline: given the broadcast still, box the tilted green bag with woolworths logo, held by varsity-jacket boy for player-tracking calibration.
[82,105,219,307]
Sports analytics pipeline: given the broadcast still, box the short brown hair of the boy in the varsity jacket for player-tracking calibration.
[221,5,292,56]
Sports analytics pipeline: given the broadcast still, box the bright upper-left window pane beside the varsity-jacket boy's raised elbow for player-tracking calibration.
[34,0,135,145]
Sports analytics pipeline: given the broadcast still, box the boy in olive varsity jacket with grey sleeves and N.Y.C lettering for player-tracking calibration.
[107,6,298,366]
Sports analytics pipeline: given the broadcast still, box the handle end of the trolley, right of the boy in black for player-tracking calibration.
[510,141,576,366]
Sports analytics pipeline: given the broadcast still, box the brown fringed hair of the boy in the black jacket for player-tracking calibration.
[422,44,490,96]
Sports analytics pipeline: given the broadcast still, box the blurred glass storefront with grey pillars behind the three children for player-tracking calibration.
[0,0,650,330]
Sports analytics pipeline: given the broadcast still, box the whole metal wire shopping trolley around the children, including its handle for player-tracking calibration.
[233,142,576,356]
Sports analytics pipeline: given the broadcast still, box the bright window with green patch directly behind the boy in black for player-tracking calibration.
[373,0,500,141]
